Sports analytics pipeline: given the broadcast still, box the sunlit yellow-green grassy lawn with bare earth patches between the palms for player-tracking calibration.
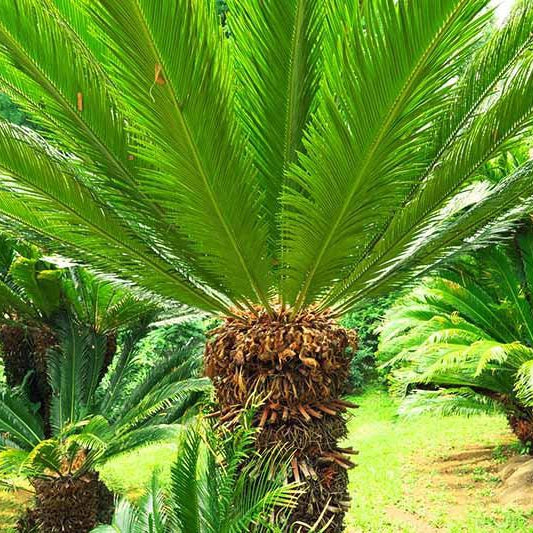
[0,389,533,533]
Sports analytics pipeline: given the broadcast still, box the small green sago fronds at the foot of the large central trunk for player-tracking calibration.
[94,423,307,533]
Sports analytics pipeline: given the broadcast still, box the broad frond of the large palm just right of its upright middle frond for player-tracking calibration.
[283,0,487,308]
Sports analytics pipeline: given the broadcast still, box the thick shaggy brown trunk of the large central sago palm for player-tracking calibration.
[206,311,356,533]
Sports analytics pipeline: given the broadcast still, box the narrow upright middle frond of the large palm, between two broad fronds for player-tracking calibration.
[227,0,324,241]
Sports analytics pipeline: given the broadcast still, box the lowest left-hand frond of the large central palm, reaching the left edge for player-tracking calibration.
[0,124,227,310]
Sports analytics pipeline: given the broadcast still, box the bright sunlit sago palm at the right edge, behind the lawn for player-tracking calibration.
[380,224,533,449]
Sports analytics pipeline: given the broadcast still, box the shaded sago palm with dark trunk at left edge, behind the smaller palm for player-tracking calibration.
[0,236,152,432]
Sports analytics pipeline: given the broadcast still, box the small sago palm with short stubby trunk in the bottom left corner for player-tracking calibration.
[0,319,211,533]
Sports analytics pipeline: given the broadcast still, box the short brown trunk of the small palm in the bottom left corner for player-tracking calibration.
[17,472,114,533]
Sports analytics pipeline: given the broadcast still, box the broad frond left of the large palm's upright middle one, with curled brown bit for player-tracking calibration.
[91,0,268,306]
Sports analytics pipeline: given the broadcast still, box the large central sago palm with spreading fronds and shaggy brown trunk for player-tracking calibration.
[0,0,533,531]
